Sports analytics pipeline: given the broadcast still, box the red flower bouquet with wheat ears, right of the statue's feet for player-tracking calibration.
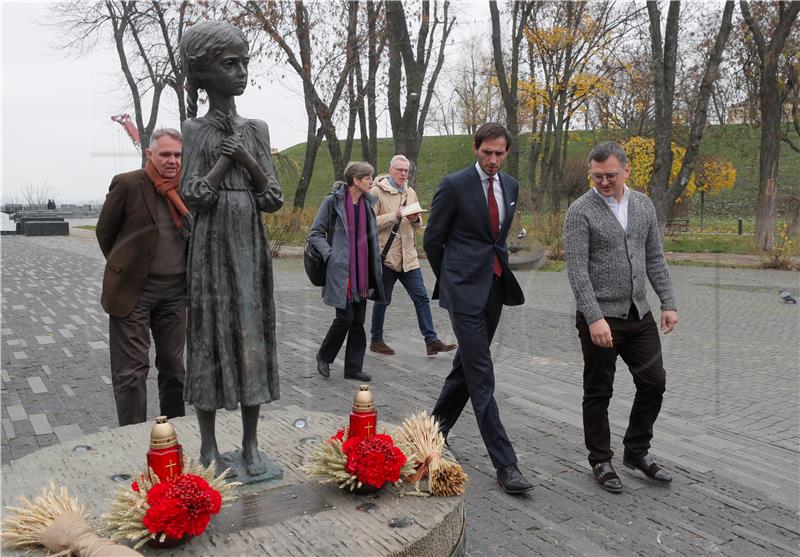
[305,429,414,491]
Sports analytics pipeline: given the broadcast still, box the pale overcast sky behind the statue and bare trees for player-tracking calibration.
[0,0,489,203]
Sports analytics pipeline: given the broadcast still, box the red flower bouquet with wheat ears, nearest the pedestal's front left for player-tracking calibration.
[104,463,240,549]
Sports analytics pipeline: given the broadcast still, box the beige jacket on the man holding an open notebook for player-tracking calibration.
[370,174,422,272]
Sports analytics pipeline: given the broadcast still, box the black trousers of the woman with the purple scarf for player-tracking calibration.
[319,301,367,373]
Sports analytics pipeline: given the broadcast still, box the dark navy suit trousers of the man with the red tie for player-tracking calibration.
[433,278,517,468]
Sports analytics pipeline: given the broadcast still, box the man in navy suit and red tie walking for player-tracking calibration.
[424,123,533,493]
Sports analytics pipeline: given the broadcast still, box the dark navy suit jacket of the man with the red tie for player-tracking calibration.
[424,165,525,315]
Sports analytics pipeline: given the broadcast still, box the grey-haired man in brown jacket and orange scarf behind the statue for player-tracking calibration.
[95,129,191,426]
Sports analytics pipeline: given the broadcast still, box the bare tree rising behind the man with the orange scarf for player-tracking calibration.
[52,0,194,166]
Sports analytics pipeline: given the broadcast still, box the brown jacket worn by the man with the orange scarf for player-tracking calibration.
[95,169,176,317]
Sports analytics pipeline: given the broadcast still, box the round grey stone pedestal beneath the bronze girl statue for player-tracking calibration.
[2,406,465,557]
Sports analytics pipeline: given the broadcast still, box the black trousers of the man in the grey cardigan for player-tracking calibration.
[575,307,666,466]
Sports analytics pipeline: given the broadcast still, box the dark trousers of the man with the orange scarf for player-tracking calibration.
[108,275,186,426]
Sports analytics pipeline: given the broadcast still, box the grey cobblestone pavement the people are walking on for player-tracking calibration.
[0,230,800,556]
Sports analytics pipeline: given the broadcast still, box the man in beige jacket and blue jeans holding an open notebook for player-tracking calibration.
[369,155,457,356]
